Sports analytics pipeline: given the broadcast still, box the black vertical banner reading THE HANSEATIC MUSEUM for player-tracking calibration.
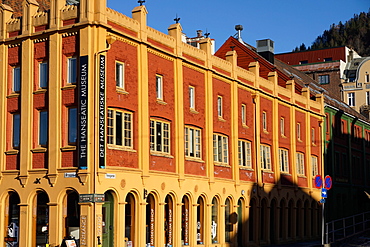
[77,56,89,170]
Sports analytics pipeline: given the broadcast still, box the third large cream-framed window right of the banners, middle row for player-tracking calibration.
[185,127,201,159]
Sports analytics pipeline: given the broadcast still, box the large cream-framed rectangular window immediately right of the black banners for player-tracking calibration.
[107,109,132,148]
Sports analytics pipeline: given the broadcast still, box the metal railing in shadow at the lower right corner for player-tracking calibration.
[325,211,370,244]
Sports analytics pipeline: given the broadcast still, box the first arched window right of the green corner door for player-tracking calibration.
[125,193,135,246]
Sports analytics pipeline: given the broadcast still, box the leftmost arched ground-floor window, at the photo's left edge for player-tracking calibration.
[4,192,20,246]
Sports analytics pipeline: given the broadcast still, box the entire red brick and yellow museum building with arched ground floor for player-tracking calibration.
[0,0,325,246]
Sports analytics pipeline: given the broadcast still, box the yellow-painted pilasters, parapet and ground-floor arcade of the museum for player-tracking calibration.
[0,0,324,247]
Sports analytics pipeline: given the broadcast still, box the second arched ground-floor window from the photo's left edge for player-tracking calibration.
[34,191,49,246]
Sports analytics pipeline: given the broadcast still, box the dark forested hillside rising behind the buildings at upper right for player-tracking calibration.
[293,9,370,56]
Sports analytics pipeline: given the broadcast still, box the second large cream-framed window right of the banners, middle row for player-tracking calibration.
[150,120,170,154]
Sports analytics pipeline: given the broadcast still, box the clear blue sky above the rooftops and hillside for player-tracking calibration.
[107,0,370,53]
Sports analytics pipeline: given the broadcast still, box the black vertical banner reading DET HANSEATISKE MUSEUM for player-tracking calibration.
[99,55,105,168]
